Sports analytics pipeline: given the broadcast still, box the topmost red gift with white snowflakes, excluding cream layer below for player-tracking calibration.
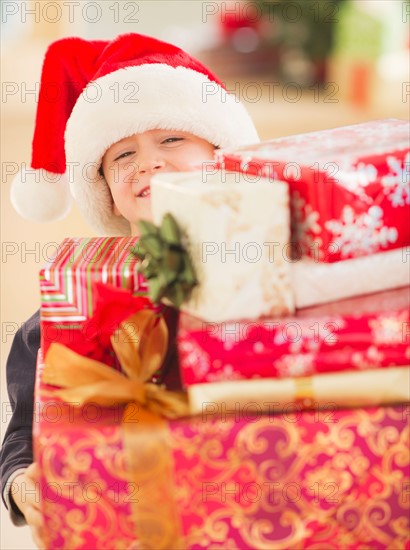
[218,119,410,262]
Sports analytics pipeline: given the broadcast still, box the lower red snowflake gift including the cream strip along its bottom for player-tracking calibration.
[178,288,410,413]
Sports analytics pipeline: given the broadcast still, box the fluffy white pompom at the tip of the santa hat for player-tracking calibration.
[10,169,72,222]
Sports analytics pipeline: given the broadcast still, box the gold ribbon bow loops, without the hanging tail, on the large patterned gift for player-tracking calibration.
[43,310,189,418]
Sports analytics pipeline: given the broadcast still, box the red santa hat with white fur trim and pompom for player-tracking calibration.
[11,34,259,235]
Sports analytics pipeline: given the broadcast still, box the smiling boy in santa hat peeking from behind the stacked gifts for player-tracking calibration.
[1,34,259,547]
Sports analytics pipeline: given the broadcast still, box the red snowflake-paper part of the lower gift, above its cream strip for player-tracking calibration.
[178,288,410,386]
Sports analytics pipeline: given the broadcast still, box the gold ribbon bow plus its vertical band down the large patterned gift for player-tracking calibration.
[43,310,189,550]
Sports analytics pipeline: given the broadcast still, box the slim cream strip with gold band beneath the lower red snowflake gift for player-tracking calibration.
[188,366,410,414]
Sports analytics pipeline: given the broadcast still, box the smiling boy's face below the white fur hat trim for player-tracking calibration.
[102,130,215,234]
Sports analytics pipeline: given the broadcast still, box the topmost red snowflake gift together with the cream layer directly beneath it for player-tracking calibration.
[219,119,410,308]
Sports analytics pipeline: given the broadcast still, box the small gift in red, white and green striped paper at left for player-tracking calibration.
[40,237,147,362]
